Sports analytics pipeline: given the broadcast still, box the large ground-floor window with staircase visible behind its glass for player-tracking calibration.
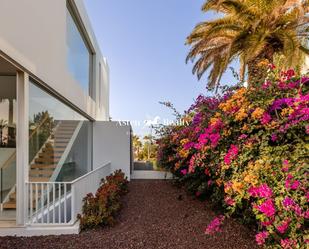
[29,83,92,182]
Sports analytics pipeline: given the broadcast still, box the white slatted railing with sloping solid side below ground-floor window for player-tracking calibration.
[27,163,111,225]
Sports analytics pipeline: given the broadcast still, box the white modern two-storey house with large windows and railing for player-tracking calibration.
[0,0,132,236]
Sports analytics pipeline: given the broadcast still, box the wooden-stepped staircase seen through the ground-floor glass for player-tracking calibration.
[3,121,79,209]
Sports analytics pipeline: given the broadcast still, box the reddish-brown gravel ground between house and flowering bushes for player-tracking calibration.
[0,180,257,249]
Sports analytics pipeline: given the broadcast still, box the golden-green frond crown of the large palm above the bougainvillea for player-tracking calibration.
[186,0,309,89]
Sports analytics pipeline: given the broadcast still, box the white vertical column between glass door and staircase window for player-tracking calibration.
[16,72,29,225]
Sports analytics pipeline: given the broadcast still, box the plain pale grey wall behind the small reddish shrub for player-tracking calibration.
[93,121,131,180]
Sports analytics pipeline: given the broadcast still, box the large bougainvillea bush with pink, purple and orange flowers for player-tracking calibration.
[157,65,309,248]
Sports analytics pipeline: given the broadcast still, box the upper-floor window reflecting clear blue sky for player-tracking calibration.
[67,8,92,94]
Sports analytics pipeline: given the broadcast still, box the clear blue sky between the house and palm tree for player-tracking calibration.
[85,0,235,135]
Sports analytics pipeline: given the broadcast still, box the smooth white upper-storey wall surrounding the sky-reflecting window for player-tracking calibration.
[0,0,109,120]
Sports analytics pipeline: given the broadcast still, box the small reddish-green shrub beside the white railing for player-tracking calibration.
[78,170,128,229]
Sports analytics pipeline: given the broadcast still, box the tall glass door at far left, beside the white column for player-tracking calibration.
[0,76,17,221]
